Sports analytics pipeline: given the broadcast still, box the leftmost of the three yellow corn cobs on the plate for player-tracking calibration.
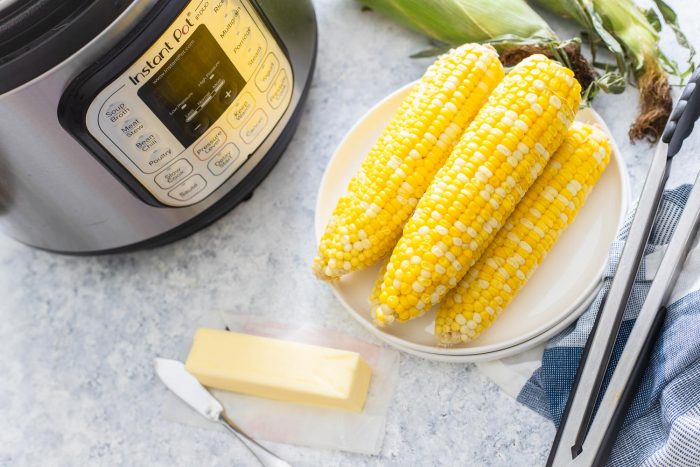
[313,44,504,280]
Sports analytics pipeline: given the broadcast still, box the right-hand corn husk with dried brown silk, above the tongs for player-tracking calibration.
[536,0,695,142]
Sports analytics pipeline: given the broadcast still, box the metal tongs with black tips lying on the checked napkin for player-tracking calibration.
[547,71,700,467]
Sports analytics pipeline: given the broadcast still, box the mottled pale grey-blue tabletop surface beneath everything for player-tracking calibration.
[0,0,700,466]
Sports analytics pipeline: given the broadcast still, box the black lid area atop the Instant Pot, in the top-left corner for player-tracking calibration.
[0,0,134,94]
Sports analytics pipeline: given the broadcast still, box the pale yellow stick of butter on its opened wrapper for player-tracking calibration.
[185,328,372,412]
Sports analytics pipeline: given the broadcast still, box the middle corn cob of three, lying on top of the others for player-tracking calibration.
[372,55,581,326]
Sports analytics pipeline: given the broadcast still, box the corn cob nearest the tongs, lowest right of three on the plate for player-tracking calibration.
[435,123,610,345]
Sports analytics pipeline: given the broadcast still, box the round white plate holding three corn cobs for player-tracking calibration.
[315,81,629,358]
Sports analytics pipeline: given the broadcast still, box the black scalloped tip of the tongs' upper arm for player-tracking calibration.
[661,70,700,159]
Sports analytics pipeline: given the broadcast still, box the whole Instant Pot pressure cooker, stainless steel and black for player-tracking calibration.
[0,0,316,253]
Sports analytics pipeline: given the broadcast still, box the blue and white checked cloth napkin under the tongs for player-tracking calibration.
[479,185,700,467]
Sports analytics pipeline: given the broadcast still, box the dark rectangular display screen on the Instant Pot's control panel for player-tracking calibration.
[138,25,246,147]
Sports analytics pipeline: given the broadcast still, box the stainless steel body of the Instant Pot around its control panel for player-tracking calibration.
[0,0,316,253]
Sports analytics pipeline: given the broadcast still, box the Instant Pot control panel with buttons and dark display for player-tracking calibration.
[86,0,293,207]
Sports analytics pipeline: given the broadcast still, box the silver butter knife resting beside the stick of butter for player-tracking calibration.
[155,358,291,467]
